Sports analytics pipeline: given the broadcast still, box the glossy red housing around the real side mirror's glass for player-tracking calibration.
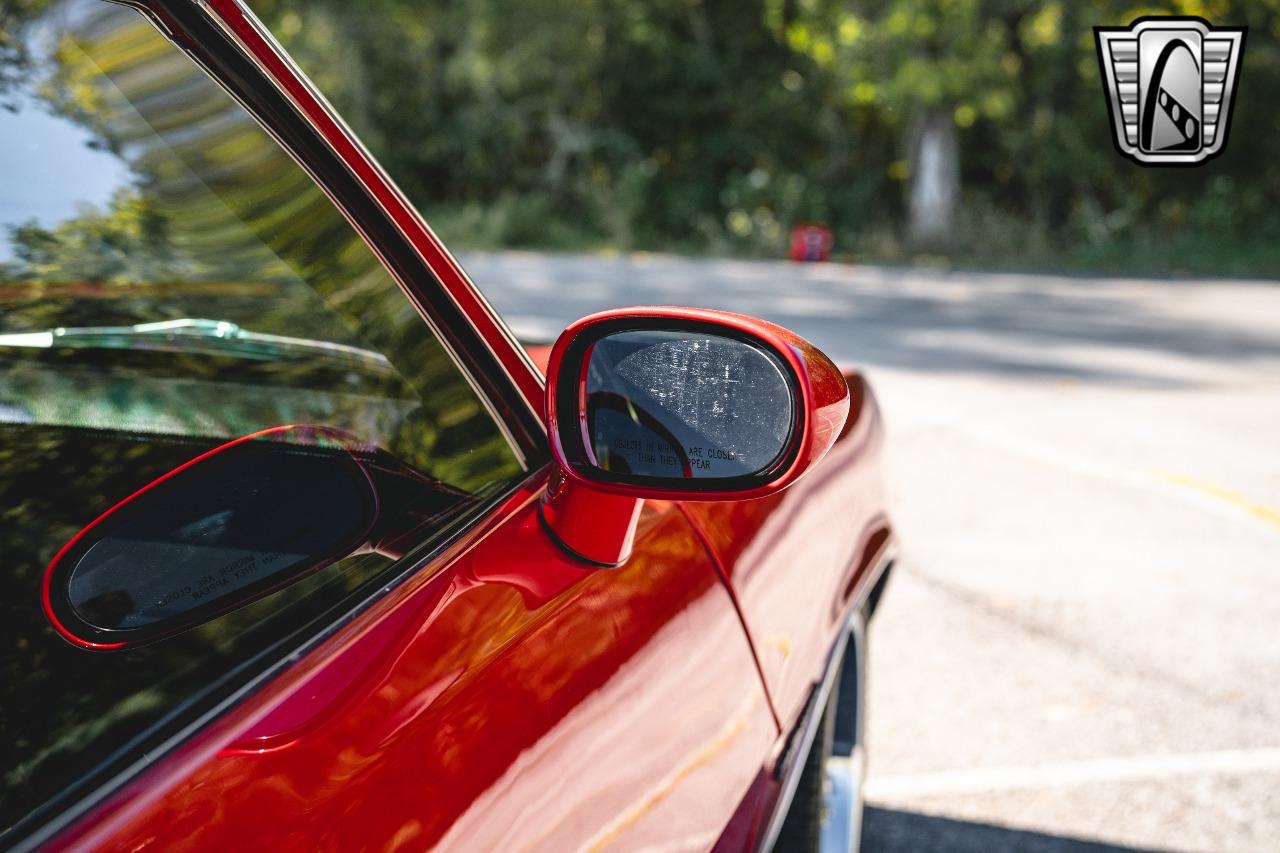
[544,306,849,501]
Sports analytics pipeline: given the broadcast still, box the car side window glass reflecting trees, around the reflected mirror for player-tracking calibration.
[0,0,521,827]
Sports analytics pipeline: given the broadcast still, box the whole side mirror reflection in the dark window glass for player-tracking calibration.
[42,425,475,652]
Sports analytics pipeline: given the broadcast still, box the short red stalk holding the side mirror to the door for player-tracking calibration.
[539,470,641,569]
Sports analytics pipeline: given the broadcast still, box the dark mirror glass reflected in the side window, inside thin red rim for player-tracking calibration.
[51,432,376,642]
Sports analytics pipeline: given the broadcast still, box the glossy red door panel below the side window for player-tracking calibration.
[47,485,780,850]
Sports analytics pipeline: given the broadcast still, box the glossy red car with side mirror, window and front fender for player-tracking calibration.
[0,0,892,850]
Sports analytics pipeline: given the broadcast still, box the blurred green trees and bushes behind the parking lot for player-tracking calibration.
[251,0,1280,275]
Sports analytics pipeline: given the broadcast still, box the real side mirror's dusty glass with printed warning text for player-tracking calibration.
[584,330,795,479]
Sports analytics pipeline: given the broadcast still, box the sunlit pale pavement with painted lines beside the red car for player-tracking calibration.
[462,254,1280,852]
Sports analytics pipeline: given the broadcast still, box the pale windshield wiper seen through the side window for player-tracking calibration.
[0,318,396,373]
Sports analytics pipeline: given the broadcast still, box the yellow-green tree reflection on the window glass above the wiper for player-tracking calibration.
[0,3,515,488]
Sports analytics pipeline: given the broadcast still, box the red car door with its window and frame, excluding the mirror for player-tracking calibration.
[0,0,778,849]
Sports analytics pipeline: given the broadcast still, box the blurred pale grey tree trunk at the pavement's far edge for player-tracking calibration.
[908,110,960,247]
